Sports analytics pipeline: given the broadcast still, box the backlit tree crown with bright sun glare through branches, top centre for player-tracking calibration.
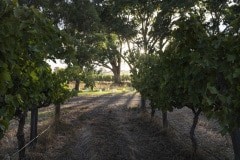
[109,0,174,64]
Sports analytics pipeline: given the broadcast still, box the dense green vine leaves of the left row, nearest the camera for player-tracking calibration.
[0,1,71,137]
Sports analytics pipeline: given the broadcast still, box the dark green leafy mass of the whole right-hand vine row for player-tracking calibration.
[132,1,240,134]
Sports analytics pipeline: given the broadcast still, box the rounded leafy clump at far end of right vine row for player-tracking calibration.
[131,55,181,111]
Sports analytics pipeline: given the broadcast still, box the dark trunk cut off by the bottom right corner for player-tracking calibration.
[230,128,240,160]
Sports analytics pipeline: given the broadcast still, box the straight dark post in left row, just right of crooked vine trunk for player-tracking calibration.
[30,105,38,149]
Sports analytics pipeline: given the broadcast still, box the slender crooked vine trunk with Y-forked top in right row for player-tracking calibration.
[190,107,202,156]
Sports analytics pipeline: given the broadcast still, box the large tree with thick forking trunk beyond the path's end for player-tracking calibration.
[95,0,137,83]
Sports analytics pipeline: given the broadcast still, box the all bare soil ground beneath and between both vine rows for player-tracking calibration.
[0,92,233,160]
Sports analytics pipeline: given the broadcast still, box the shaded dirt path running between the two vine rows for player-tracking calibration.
[50,94,186,160]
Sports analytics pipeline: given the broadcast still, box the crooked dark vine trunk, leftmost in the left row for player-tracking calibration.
[17,111,27,160]
